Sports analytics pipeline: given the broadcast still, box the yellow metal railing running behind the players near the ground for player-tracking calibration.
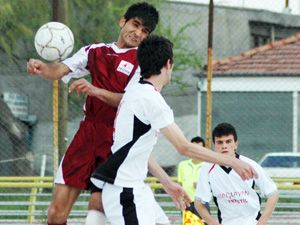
[0,177,300,225]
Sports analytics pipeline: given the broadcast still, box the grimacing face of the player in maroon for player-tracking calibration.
[117,17,150,48]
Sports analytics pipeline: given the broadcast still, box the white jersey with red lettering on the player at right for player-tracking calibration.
[195,154,277,225]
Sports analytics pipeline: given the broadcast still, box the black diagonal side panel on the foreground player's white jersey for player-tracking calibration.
[92,116,151,184]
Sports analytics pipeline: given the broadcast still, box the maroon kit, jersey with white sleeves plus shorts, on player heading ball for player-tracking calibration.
[55,43,140,189]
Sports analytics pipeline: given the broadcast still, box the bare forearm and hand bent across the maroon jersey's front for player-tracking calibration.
[69,78,123,107]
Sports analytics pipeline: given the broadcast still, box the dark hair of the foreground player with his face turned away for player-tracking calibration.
[137,35,173,78]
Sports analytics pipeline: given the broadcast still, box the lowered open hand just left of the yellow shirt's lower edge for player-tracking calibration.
[163,181,192,210]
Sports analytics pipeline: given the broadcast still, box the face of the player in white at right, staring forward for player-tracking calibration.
[214,134,238,156]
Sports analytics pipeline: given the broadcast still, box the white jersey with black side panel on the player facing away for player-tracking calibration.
[91,80,174,188]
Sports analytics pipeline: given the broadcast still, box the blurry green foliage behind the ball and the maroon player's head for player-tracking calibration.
[0,0,201,77]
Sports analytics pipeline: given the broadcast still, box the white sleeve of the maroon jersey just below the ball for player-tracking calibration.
[62,46,90,83]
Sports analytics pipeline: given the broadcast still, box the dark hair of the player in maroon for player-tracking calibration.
[124,2,159,33]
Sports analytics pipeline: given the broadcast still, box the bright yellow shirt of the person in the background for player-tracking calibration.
[177,159,203,201]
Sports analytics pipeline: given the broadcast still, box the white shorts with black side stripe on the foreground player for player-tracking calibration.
[102,183,169,225]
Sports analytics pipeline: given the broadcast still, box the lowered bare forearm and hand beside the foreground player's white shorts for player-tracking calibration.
[148,156,192,210]
